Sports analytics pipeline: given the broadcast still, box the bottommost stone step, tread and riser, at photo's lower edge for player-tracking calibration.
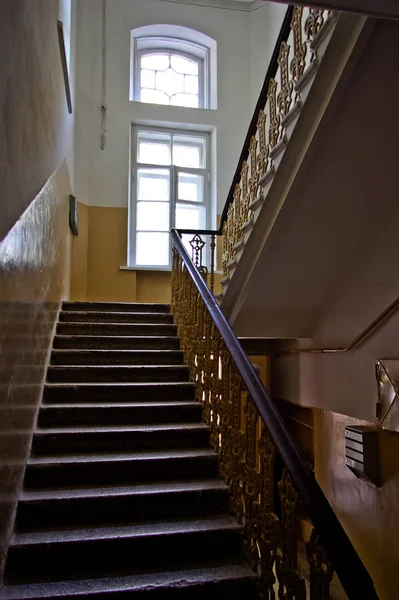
[2,561,258,600]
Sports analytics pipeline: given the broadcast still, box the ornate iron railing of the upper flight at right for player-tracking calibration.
[179,6,333,290]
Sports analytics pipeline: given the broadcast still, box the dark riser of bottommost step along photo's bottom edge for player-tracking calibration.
[2,577,258,600]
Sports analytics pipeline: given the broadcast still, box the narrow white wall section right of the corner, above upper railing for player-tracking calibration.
[249,2,287,111]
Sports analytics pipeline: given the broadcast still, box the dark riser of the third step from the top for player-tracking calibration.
[57,323,177,336]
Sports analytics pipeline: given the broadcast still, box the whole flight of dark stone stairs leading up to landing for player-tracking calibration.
[2,302,257,600]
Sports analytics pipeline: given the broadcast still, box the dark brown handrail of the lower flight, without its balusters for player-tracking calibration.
[171,229,378,600]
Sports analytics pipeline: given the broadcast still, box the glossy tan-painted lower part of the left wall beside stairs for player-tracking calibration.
[0,163,71,571]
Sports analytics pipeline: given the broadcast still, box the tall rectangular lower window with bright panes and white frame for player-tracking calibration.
[128,128,209,268]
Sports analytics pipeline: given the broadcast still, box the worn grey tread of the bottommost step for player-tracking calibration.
[2,562,257,600]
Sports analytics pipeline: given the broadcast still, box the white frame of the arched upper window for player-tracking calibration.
[131,35,210,110]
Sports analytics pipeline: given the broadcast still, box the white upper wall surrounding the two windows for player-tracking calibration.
[75,0,286,212]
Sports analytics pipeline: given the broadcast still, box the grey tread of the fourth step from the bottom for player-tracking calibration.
[28,448,218,465]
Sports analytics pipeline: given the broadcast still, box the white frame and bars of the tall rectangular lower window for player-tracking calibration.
[127,123,212,271]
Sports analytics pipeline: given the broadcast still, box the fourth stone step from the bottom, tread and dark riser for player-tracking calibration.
[24,448,219,489]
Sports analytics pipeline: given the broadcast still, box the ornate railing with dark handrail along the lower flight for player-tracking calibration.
[171,230,377,600]
